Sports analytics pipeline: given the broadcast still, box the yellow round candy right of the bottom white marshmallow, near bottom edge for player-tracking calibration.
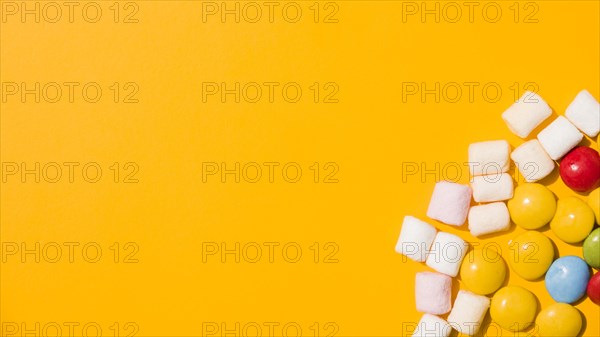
[490,286,537,331]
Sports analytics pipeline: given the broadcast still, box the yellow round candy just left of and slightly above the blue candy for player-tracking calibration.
[508,231,554,281]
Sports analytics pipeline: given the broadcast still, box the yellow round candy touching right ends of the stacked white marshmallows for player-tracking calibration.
[508,183,556,229]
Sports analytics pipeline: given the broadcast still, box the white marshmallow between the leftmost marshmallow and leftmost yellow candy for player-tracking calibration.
[425,232,469,277]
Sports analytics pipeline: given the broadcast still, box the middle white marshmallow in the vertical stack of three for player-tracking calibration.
[471,173,514,202]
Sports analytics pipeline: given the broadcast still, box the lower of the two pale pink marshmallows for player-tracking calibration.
[415,272,452,315]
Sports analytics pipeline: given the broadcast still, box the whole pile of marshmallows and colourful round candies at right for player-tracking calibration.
[396,90,600,337]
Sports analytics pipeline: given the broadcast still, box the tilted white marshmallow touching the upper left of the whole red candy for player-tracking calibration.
[538,116,583,160]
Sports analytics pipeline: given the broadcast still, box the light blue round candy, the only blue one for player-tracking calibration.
[546,256,590,303]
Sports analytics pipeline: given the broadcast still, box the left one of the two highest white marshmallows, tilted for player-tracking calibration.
[502,91,552,138]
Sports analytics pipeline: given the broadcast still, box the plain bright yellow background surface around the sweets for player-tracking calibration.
[0,1,600,336]
